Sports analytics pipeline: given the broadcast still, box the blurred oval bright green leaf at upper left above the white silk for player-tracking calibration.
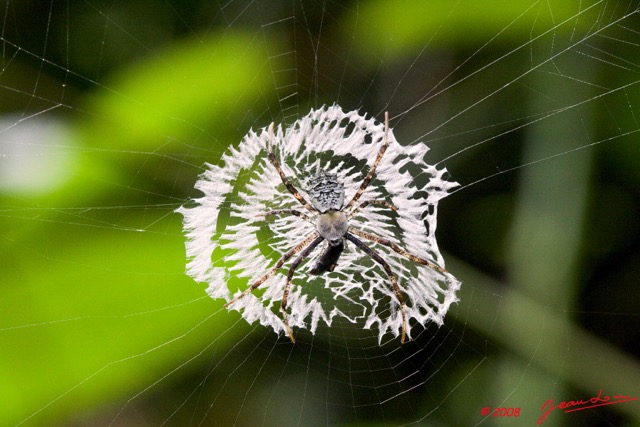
[86,32,277,149]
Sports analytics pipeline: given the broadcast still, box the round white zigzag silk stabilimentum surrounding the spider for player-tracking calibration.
[177,105,460,341]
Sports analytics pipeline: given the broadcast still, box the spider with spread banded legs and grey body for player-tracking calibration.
[225,112,447,344]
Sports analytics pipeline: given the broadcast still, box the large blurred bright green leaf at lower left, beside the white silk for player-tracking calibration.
[0,216,244,425]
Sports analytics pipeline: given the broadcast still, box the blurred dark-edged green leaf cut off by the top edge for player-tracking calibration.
[350,0,597,61]
